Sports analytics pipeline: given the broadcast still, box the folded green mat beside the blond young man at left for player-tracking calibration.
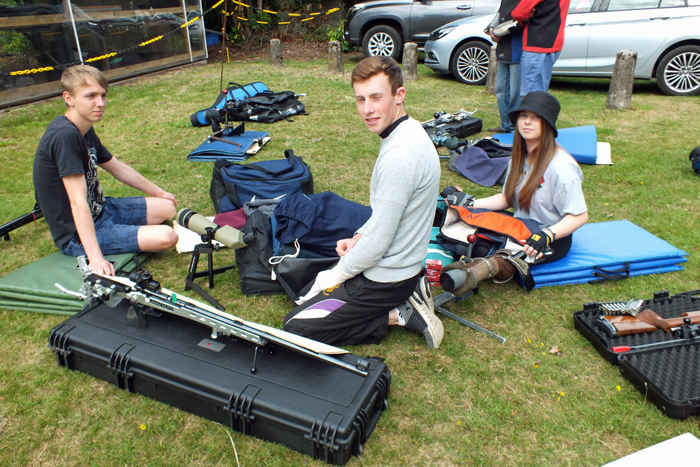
[0,252,152,315]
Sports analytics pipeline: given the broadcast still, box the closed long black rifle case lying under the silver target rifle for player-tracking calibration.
[49,300,391,465]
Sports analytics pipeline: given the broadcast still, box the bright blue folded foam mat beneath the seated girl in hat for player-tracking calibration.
[530,220,688,288]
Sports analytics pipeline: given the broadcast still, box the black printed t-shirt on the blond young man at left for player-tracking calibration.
[34,115,112,250]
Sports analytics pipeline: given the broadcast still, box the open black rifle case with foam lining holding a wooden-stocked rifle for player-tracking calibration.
[574,290,700,419]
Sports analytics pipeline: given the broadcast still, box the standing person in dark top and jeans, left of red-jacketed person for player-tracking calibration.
[485,0,523,133]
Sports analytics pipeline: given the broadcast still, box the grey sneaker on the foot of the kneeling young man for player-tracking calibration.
[399,276,444,349]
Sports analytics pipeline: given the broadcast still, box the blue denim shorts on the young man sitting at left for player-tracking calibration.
[63,196,148,256]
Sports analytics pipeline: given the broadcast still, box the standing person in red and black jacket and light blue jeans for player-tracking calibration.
[511,0,569,96]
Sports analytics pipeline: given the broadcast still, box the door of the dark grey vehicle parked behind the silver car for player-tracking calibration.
[409,0,478,44]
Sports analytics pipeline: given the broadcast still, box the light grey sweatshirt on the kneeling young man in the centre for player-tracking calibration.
[340,118,440,283]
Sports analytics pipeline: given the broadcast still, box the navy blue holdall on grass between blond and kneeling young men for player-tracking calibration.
[209,149,314,213]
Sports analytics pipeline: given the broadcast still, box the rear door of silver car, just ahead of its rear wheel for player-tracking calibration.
[586,0,686,78]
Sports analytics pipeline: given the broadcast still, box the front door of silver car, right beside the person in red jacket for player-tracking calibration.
[552,0,601,75]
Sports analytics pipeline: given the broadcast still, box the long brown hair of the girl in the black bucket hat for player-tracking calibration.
[504,118,558,212]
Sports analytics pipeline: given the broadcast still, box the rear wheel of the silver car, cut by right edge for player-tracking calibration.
[656,45,700,96]
